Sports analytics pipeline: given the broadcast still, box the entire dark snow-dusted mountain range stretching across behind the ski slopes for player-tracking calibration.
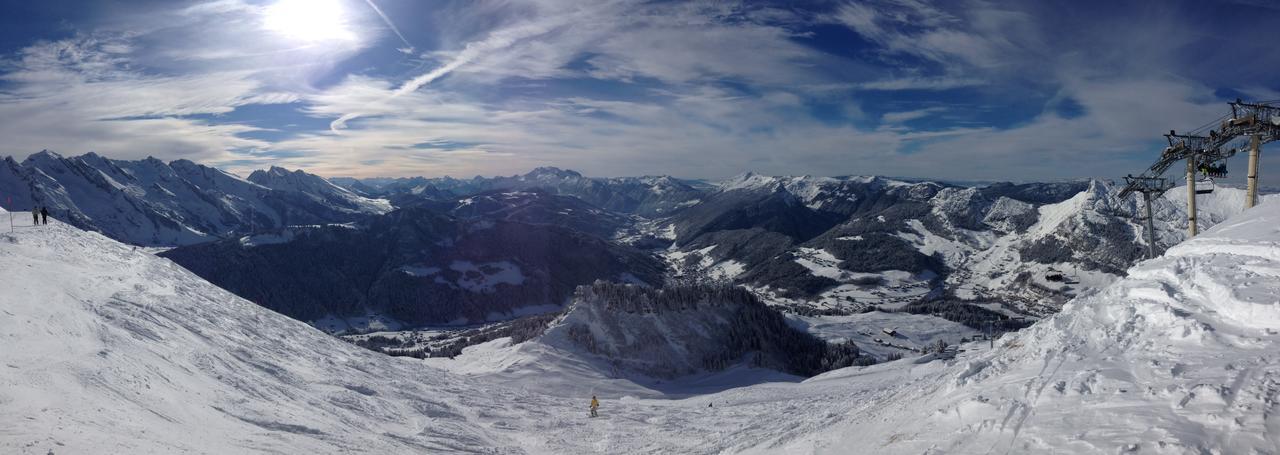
[0,153,1270,359]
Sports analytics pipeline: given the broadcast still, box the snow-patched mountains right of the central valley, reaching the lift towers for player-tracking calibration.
[653,174,1271,317]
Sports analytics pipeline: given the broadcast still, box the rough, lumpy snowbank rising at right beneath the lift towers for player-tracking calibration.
[780,190,1280,454]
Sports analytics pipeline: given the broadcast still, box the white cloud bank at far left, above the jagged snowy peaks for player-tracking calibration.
[0,37,275,159]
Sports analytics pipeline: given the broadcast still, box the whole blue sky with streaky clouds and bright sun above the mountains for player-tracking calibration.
[0,0,1280,181]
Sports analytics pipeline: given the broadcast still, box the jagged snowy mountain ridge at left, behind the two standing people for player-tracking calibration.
[0,151,390,246]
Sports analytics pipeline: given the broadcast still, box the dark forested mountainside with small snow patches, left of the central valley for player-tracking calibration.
[163,209,663,326]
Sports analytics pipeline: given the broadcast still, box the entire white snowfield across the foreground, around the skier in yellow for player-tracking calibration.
[0,201,1280,454]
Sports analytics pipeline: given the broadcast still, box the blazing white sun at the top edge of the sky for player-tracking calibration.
[262,0,356,42]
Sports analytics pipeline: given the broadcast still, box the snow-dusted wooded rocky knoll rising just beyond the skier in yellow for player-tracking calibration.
[540,282,869,378]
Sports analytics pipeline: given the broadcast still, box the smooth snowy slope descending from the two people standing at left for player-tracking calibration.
[0,217,518,454]
